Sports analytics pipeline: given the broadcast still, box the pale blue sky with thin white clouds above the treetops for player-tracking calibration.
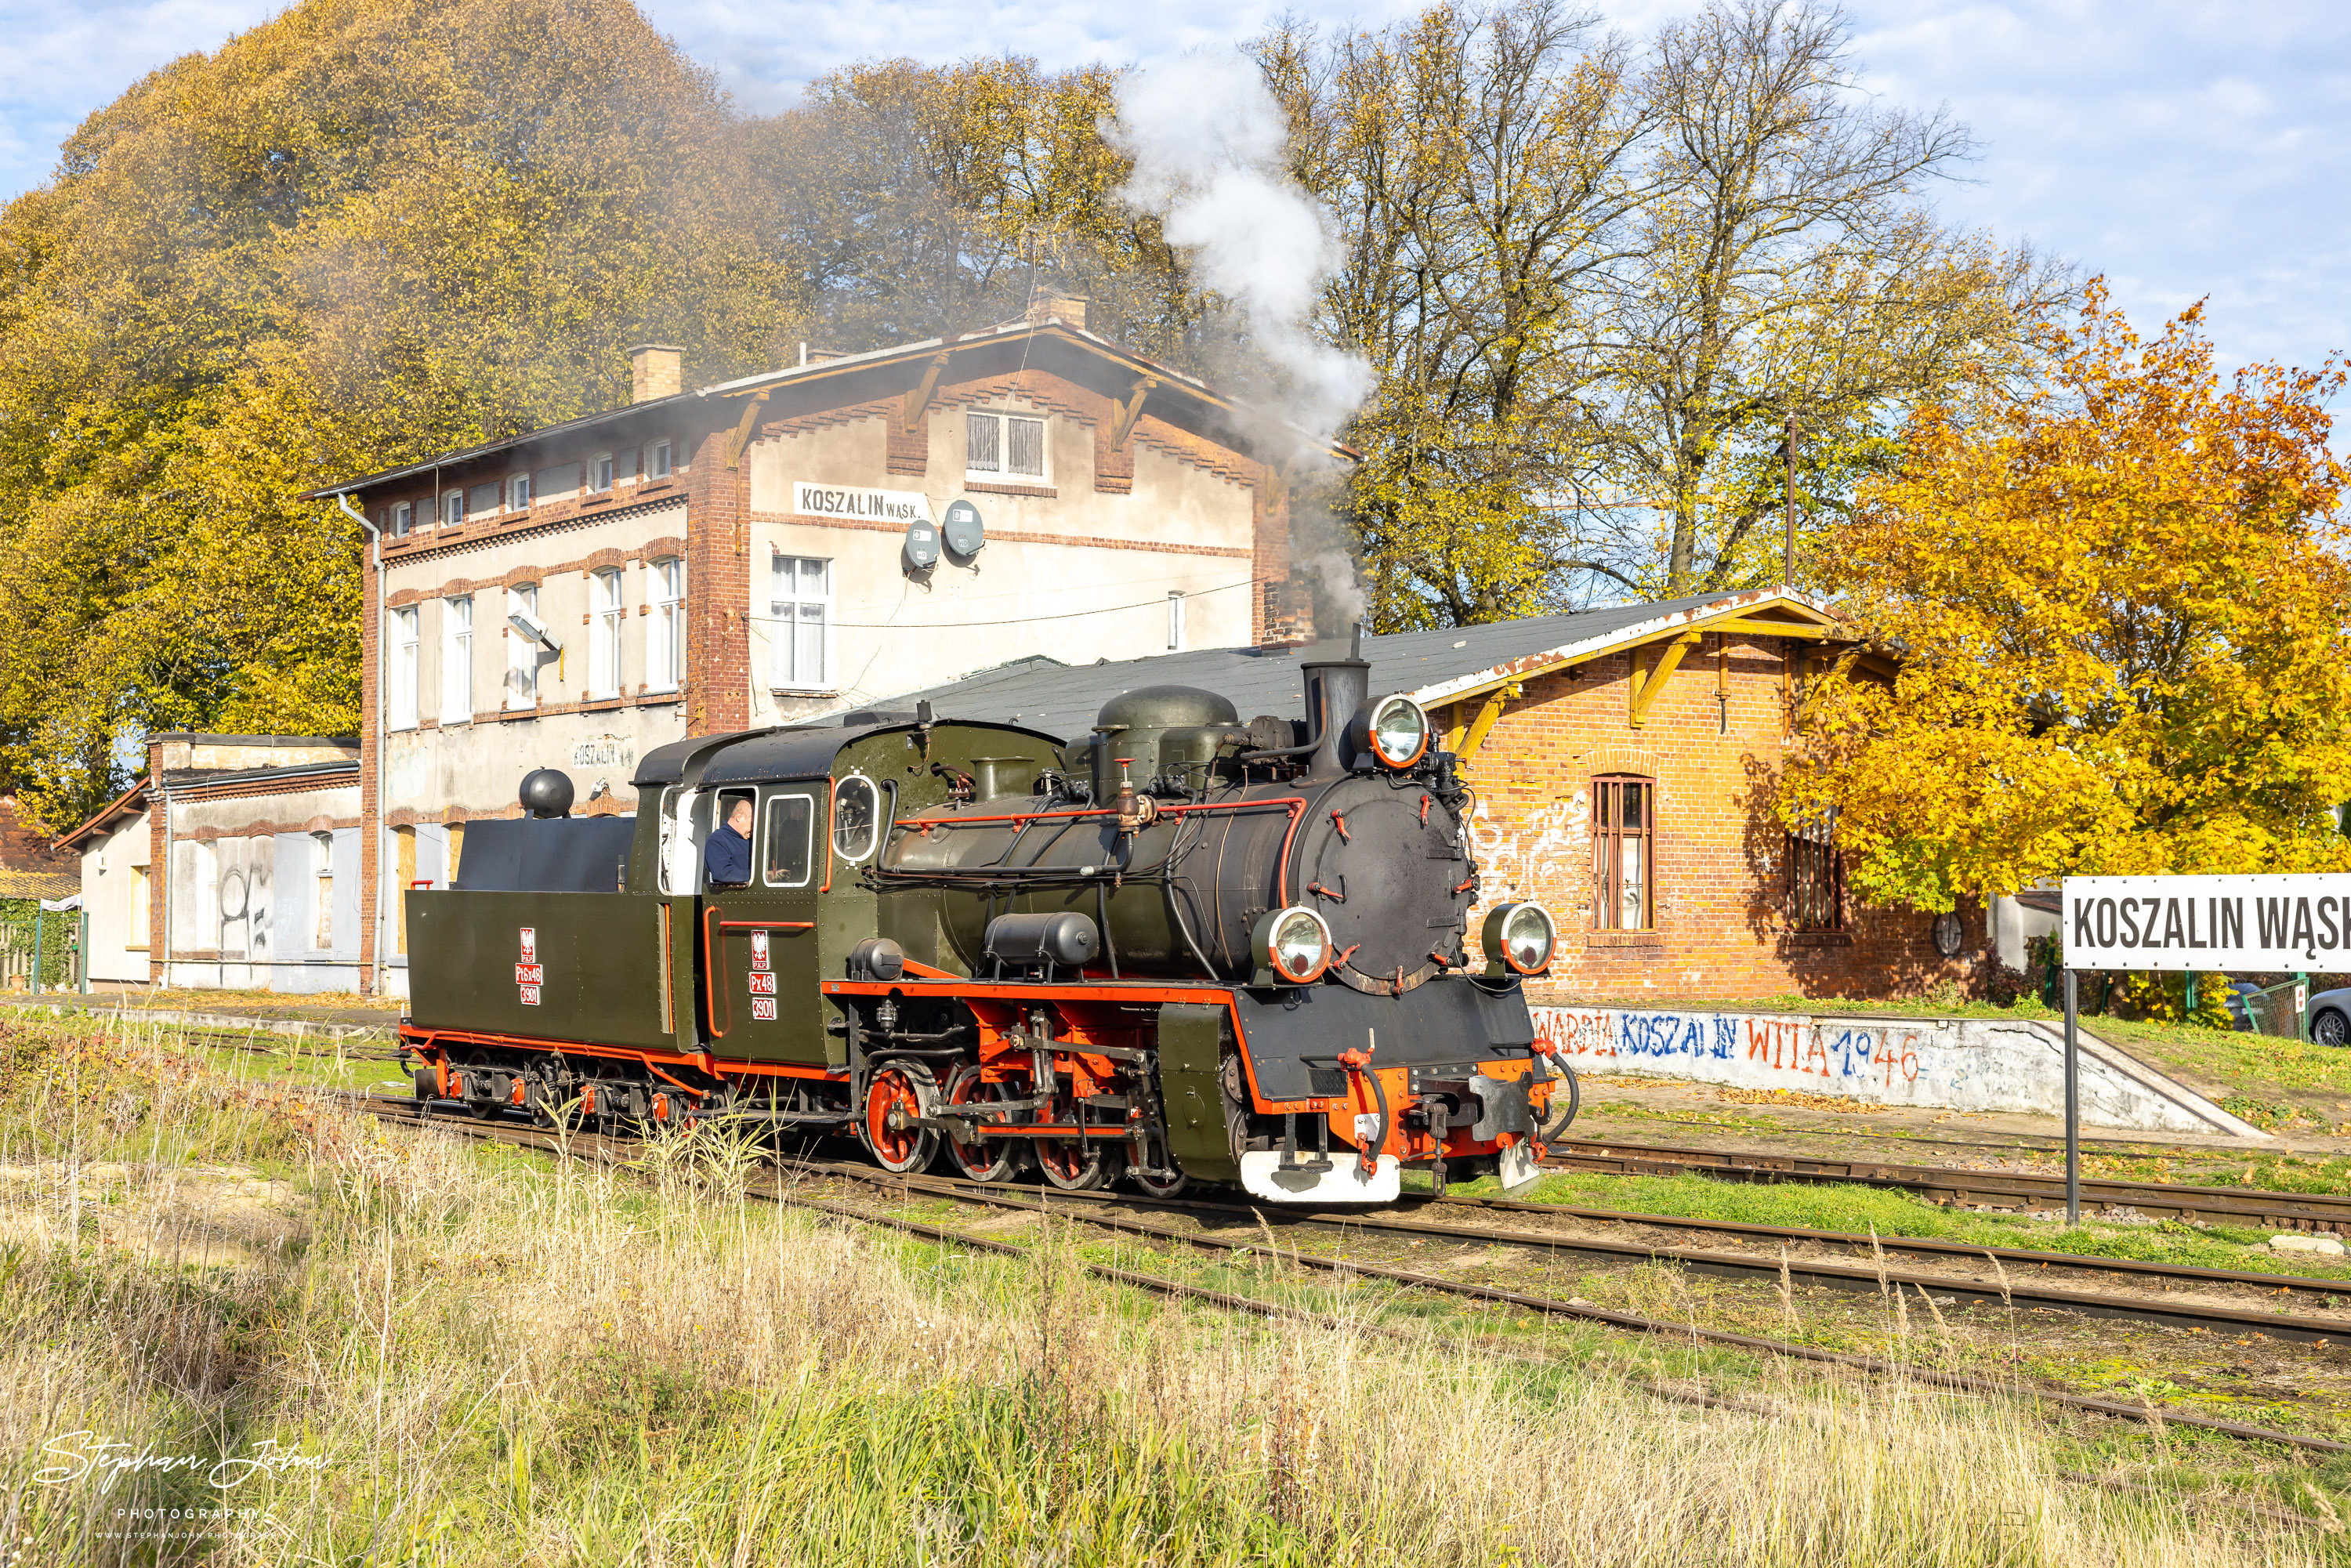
[0,0,2351,378]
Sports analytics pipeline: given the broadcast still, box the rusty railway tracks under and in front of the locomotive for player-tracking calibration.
[343,1098,2351,1453]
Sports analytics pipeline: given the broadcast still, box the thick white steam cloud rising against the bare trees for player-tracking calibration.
[1105,54,1371,451]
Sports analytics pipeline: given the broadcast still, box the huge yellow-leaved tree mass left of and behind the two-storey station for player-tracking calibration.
[0,0,792,825]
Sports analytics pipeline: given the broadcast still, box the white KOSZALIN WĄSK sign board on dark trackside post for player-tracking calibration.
[2064,872,2351,971]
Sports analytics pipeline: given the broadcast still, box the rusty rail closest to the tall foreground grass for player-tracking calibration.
[348,1100,2351,1453]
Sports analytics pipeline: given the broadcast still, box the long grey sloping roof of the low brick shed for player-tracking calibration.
[875,590,1827,738]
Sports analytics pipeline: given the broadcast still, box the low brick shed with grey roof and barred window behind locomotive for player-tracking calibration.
[889,590,1987,1001]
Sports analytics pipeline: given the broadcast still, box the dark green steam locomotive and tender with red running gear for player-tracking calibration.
[400,651,1575,1204]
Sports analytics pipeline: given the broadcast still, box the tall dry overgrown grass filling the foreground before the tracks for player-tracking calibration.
[0,1025,2325,1568]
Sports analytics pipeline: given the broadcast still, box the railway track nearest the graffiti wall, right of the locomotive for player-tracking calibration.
[1545,1138,2351,1234]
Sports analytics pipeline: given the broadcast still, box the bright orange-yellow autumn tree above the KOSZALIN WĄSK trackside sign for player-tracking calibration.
[1780,287,2351,910]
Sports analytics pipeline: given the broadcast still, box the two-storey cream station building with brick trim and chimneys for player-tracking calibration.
[313,296,1335,992]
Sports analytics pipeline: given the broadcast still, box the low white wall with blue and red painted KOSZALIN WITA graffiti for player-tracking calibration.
[1533,1006,1942,1100]
